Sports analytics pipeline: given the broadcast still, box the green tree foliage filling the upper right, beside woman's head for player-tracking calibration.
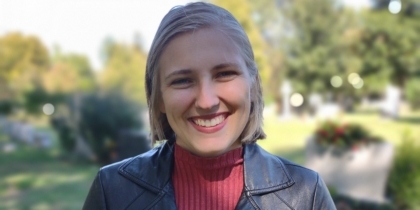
[250,0,420,108]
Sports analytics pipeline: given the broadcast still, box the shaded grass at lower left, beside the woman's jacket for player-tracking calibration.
[0,130,99,210]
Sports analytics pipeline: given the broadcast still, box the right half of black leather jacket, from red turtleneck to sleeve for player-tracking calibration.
[244,144,335,209]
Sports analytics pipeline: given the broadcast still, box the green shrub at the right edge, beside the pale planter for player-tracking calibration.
[387,132,420,209]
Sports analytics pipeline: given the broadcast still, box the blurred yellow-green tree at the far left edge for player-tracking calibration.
[0,33,50,111]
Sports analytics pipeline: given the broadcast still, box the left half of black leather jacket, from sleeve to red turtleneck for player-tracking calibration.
[84,144,174,209]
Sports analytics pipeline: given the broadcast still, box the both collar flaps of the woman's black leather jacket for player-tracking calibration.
[118,142,294,195]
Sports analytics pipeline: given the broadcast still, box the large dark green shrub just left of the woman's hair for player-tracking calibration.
[79,93,143,163]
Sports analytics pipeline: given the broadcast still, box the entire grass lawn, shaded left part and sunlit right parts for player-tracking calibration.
[0,109,420,210]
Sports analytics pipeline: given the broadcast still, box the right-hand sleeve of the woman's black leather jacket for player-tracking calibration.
[312,174,337,210]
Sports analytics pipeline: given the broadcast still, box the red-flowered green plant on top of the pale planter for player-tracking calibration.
[315,121,382,149]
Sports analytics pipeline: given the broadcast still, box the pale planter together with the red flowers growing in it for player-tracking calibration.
[305,121,394,203]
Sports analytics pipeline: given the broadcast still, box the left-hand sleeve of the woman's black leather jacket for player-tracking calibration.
[83,171,107,210]
